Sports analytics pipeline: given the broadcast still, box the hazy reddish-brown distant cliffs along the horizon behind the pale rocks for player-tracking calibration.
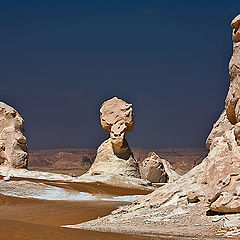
[28,148,207,171]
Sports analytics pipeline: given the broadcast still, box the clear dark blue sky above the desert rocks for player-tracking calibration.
[0,0,240,149]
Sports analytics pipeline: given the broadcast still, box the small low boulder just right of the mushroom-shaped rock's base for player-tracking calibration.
[140,152,179,183]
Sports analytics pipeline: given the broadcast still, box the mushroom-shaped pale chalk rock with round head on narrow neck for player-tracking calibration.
[84,97,140,178]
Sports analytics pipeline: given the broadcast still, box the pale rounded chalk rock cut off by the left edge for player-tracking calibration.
[0,102,28,168]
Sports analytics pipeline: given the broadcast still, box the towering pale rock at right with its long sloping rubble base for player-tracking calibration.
[67,15,240,237]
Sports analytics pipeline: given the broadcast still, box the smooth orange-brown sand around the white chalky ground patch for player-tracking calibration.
[0,178,159,240]
